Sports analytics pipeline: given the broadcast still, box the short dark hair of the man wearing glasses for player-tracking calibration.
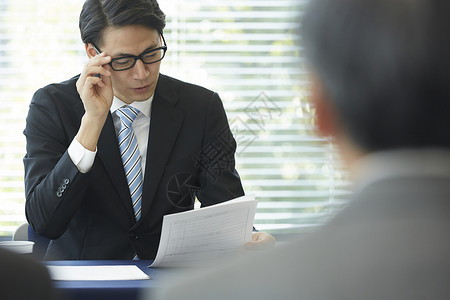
[79,0,166,47]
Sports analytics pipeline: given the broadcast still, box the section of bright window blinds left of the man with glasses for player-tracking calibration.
[0,0,85,235]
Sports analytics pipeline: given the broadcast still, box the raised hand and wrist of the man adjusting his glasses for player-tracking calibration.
[75,53,114,151]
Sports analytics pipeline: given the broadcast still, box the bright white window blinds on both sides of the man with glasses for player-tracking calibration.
[0,0,348,236]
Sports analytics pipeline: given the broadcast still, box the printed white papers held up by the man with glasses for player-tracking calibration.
[149,195,257,267]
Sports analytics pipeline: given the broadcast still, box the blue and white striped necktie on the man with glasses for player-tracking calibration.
[116,106,143,221]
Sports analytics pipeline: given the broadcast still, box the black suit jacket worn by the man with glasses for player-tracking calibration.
[24,75,244,259]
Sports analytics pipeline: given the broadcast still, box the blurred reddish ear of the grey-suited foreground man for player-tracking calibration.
[311,75,337,136]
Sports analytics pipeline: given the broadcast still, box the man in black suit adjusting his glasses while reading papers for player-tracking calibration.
[24,0,273,259]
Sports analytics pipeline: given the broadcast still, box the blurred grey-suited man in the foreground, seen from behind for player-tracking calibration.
[154,0,450,300]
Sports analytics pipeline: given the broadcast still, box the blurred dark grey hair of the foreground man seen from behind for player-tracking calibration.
[302,0,450,152]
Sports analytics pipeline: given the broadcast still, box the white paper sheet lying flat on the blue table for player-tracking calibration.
[47,265,150,281]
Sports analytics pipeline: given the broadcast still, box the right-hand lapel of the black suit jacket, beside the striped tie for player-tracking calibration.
[141,75,184,225]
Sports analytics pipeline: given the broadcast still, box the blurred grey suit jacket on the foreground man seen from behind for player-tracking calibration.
[156,150,450,300]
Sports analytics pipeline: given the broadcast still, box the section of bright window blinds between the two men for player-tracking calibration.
[161,0,349,236]
